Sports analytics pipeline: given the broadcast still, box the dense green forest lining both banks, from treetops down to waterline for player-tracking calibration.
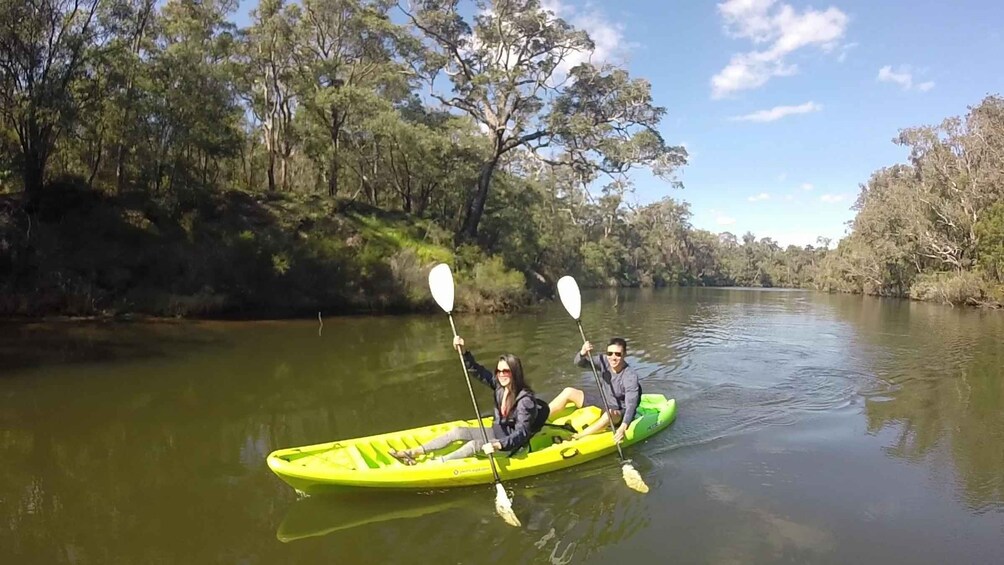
[0,0,1004,316]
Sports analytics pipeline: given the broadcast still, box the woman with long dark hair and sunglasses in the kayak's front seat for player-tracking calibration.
[391,335,549,465]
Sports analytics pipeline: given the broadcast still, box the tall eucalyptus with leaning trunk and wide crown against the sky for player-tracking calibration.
[406,0,686,240]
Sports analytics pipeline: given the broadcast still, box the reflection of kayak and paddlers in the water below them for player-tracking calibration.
[276,464,652,565]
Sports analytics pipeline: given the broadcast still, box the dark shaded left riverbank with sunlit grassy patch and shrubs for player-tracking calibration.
[0,184,530,318]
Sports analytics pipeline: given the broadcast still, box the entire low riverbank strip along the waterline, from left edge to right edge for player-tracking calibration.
[0,183,1004,320]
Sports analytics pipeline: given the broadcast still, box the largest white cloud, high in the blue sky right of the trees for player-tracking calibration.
[711,0,848,98]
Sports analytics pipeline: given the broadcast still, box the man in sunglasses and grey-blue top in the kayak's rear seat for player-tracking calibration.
[550,337,642,444]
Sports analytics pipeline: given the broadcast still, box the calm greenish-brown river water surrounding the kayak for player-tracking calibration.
[0,289,1004,564]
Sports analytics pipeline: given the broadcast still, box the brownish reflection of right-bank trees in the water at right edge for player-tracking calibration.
[858,303,1004,512]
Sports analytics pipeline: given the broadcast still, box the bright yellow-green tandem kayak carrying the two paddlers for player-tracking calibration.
[267,393,676,495]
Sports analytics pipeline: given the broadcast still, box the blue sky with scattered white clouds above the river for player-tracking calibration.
[230,0,1004,246]
